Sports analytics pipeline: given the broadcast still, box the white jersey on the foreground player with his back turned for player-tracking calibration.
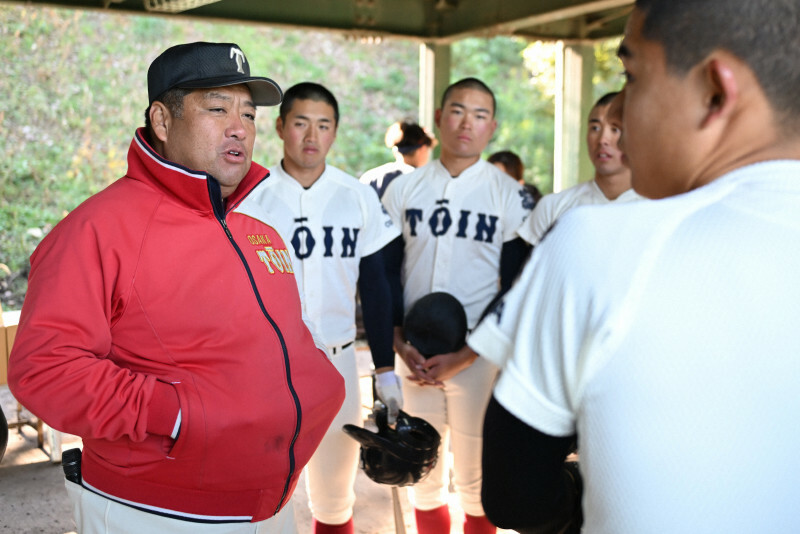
[469,161,800,534]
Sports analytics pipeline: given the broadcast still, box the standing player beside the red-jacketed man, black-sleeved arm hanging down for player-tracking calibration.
[238,82,402,534]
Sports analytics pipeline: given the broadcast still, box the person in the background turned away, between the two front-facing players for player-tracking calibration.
[359,122,436,201]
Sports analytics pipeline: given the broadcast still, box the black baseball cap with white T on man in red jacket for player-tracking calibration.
[147,42,283,106]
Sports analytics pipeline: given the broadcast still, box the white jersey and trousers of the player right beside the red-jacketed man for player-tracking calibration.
[239,165,400,525]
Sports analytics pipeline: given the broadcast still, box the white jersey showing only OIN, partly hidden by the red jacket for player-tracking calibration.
[240,165,400,346]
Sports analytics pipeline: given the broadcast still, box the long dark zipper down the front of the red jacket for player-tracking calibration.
[211,175,303,515]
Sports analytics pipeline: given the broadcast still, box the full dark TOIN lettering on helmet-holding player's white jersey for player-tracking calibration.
[406,199,498,243]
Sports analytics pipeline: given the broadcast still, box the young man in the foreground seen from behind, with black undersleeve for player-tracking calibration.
[475,0,800,534]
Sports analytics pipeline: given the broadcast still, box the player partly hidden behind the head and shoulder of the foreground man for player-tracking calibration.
[520,92,642,249]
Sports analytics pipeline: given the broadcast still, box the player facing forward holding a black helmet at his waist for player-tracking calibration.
[383,78,533,534]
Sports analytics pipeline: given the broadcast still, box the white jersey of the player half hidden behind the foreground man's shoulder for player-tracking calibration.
[517,180,643,246]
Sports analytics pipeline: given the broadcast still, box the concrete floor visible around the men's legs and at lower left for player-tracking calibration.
[0,349,490,534]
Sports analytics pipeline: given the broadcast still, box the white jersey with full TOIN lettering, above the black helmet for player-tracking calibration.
[383,160,533,328]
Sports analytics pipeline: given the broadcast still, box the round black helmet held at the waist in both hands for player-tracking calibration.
[403,291,467,358]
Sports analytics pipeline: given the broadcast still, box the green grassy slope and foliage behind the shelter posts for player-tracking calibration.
[0,5,621,310]
